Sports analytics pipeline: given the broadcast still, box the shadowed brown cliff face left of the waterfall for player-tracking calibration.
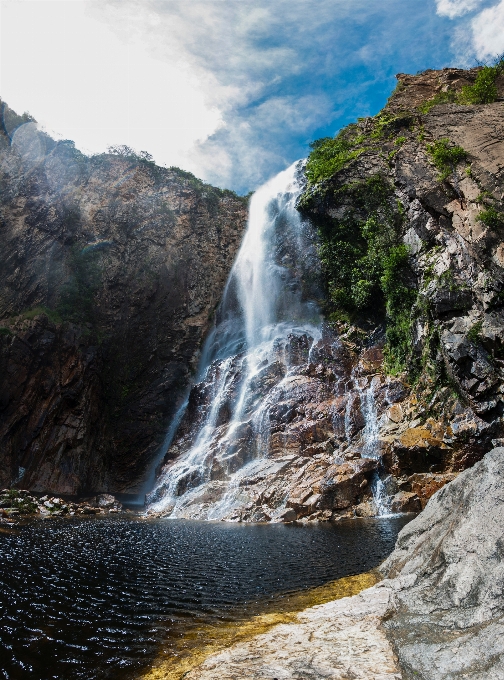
[0,105,247,494]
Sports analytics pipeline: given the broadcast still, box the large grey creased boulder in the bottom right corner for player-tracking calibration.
[380,448,504,680]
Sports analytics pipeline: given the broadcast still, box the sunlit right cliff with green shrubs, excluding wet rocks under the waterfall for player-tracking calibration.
[292,69,504,509]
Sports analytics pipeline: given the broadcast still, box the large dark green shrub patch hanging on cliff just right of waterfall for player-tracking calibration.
[320,175,417,373]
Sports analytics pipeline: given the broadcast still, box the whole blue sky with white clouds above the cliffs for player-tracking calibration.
[0,0,504,193]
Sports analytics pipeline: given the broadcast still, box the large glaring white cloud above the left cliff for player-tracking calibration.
[0,0,222,171]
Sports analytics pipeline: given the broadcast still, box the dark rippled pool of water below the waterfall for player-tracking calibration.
[0,517,408,680]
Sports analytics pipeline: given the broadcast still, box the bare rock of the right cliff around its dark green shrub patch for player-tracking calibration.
[294,69,504,509]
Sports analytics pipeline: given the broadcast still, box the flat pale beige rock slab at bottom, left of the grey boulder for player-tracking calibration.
[184,586,402,680]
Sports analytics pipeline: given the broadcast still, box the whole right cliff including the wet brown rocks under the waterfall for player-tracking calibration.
[152,63,504,521]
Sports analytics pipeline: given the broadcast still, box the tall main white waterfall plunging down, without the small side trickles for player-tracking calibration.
[147,163,321,519]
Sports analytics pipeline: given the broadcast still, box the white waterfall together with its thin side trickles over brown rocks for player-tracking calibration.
[147,163,396,521]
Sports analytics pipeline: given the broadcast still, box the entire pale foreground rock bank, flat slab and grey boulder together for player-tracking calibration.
[146,448,504,680]
